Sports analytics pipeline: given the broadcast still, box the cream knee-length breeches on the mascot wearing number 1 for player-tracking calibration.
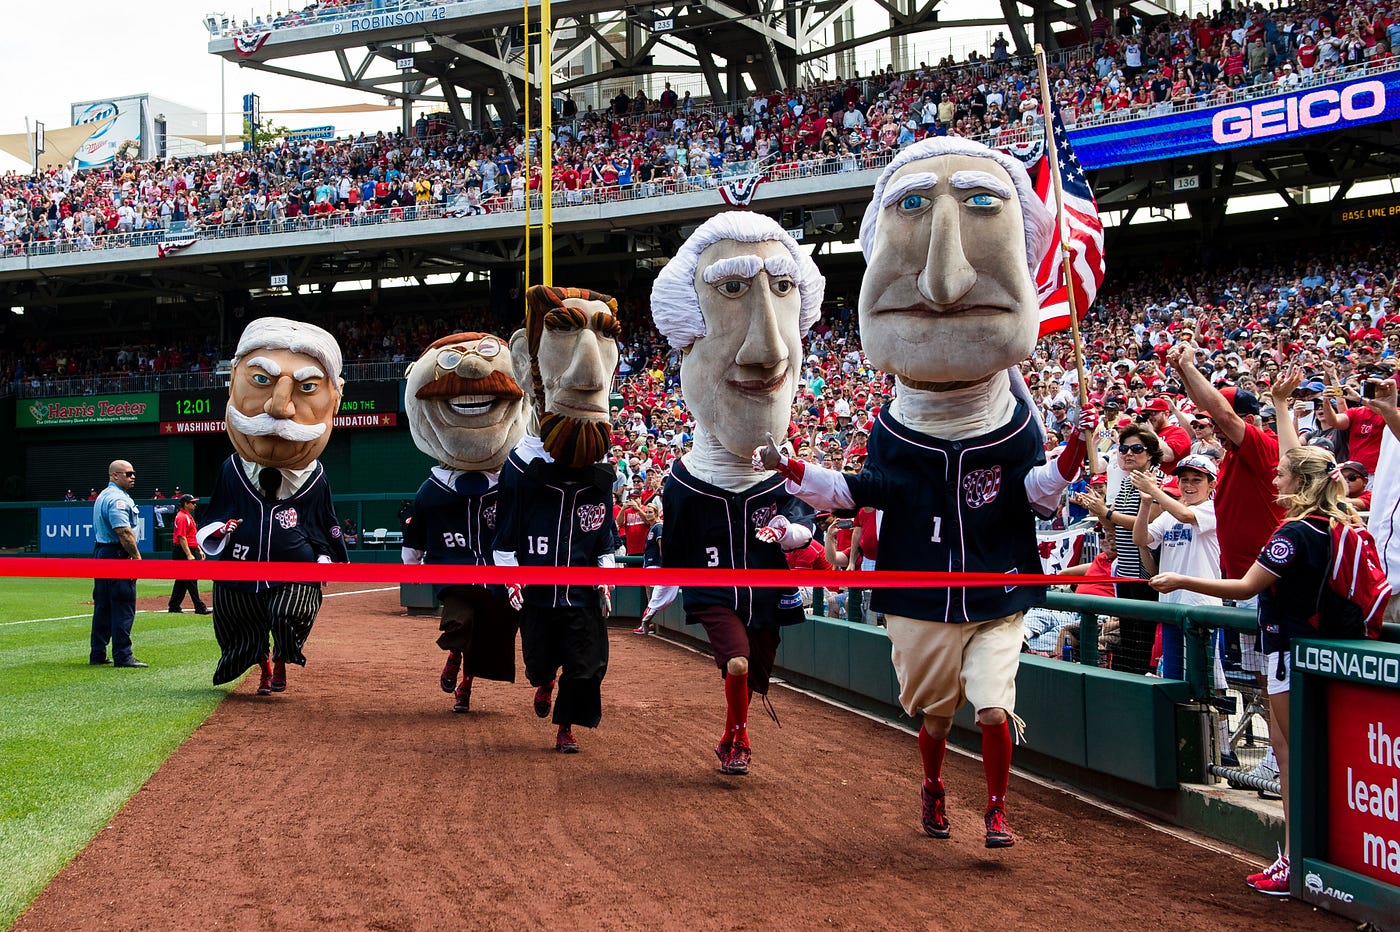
[885,612,1025,718]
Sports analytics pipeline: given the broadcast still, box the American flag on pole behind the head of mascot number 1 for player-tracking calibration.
[1032,104,1103,336]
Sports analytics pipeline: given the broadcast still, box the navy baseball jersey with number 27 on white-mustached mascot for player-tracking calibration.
[204,453,350,592]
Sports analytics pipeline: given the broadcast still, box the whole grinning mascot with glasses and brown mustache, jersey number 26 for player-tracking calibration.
[403,333,525,712]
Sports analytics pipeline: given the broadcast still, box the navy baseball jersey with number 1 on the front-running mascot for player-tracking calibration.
[846,400,1046,621]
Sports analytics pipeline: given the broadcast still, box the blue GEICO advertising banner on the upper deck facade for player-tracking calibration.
[1070,71,1400,168]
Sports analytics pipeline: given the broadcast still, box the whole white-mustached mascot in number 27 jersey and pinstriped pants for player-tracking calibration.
[197,318,349,696]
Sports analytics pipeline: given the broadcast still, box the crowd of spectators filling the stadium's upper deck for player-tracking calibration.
[0,3,1400,256]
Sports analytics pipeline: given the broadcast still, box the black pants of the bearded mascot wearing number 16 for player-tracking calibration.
[521,605,608,728]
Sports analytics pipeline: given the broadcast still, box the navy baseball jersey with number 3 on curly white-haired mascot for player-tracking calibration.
[661,459,816,628]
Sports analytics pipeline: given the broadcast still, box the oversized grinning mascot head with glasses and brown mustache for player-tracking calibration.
[403,333,525,473]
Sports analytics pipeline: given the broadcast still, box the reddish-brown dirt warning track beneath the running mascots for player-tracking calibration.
[15,585,1350,932]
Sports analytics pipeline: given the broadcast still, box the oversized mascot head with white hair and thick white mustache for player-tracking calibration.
[224,318,344,469]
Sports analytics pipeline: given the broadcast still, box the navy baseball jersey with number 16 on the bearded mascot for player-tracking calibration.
[493,449,617,609]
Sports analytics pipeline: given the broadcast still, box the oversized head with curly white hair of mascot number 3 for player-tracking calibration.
[651,210,826,459]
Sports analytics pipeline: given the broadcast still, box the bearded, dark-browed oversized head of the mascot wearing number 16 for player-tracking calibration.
[511,285,622,466]
